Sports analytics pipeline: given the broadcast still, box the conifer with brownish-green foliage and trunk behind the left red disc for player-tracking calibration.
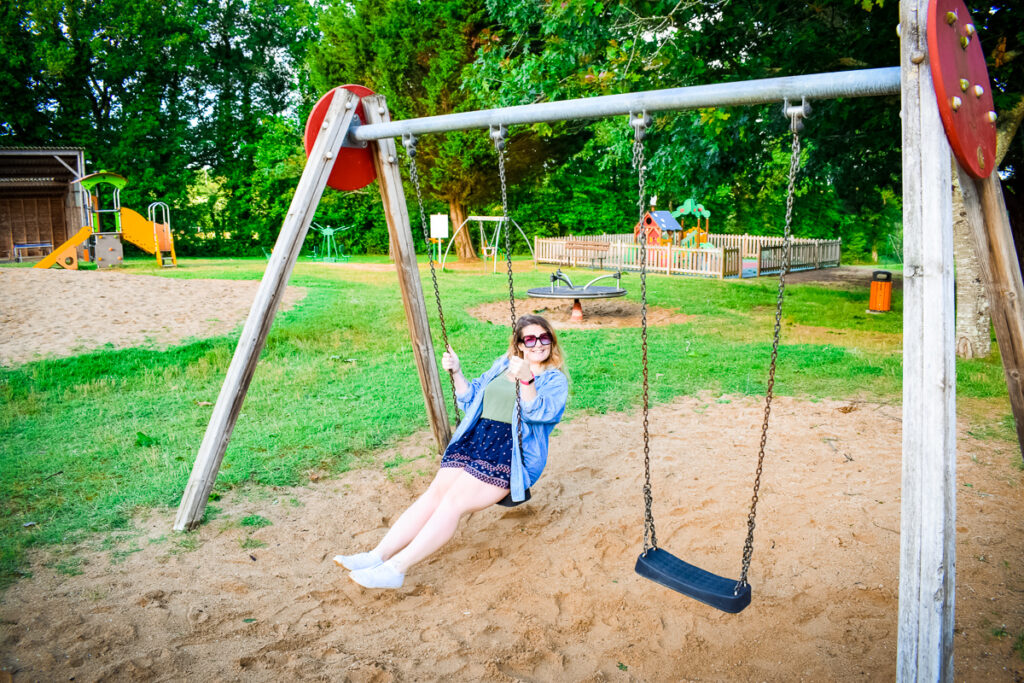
[310,0,586,260]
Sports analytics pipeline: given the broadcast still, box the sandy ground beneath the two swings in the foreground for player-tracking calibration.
[0,264,1024,682]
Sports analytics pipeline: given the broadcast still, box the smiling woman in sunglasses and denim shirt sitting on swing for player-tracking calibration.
[334,315,568,588]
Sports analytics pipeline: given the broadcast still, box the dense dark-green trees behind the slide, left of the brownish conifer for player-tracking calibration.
[0,0,312,253]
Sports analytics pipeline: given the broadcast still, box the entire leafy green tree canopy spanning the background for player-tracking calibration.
[0,0,1024,255]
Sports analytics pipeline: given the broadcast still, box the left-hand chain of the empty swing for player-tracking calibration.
[630,112,657,555]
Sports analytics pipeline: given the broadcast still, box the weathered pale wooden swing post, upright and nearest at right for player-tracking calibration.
[896,0,956,681]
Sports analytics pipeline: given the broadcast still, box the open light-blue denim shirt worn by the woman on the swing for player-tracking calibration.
[452,355,569,501]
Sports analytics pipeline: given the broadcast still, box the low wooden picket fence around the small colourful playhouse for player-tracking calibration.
[534,232,842,279]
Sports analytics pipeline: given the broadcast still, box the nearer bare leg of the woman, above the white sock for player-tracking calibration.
[389,470,509,573]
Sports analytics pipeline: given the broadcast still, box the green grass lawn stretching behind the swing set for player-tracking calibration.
[0,257,1014,586]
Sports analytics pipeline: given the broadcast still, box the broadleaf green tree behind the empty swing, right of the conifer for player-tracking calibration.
[472,0,900,253]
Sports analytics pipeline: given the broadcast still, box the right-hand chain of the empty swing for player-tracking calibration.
[736,98,811,592]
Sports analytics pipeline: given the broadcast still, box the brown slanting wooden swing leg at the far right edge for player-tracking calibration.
[956,164,1024,456]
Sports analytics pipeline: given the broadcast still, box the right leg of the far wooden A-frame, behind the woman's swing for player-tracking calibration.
[362,95,452,453]
